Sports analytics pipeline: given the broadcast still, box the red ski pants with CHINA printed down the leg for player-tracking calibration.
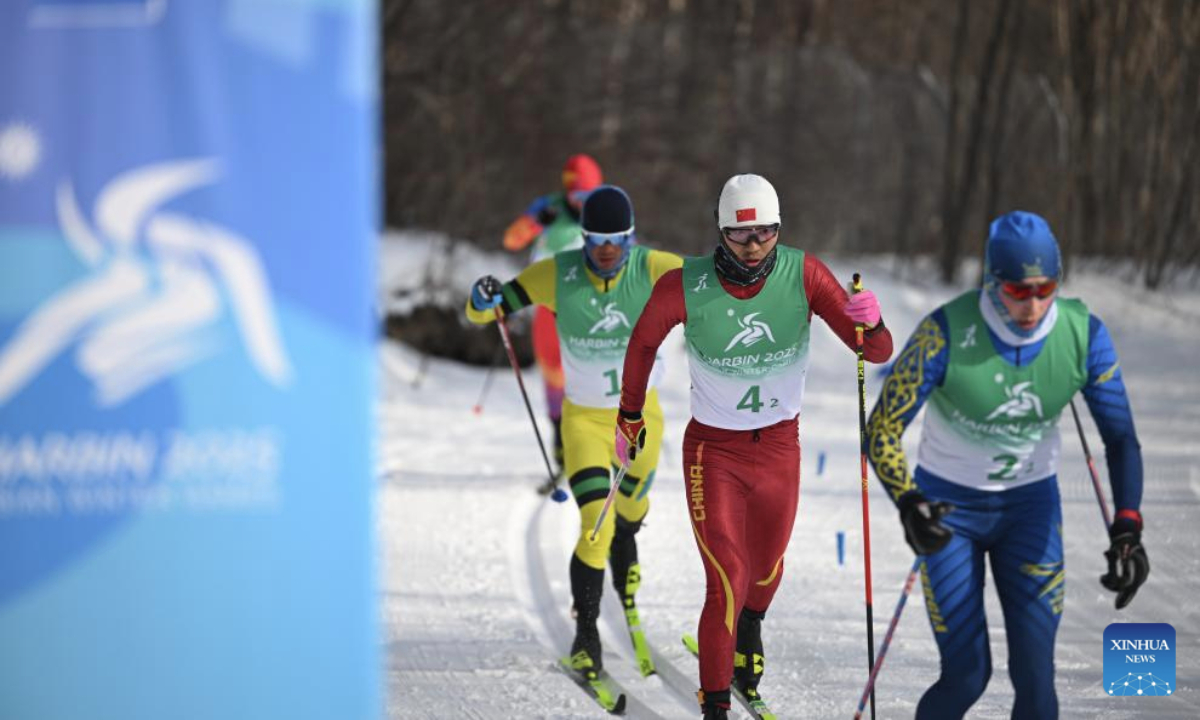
[683,418,800,692]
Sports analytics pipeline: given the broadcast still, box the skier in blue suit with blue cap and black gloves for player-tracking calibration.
[868,211,1150,720]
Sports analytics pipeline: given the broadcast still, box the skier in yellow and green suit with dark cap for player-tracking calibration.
[467,185,683,677]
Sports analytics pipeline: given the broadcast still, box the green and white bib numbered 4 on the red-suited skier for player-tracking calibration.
[683,246,809,430]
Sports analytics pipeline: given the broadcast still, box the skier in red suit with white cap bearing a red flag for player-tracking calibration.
[617,175,892,718]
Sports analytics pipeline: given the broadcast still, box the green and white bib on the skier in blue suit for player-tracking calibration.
[918,290,1088,491]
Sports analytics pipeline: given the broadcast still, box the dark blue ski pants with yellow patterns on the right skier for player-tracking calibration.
[914,467,1064,720]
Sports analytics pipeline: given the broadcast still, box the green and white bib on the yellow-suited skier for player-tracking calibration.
[554,245,664,408]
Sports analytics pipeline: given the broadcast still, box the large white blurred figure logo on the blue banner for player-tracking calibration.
[0,160,292,407]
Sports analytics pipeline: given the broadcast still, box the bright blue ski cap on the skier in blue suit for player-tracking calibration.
[984,210,1062,283]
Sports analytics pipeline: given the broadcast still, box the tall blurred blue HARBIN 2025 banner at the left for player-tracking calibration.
[0,0,380,719]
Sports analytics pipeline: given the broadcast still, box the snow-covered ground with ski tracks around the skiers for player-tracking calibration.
[378,235,1200,720]
